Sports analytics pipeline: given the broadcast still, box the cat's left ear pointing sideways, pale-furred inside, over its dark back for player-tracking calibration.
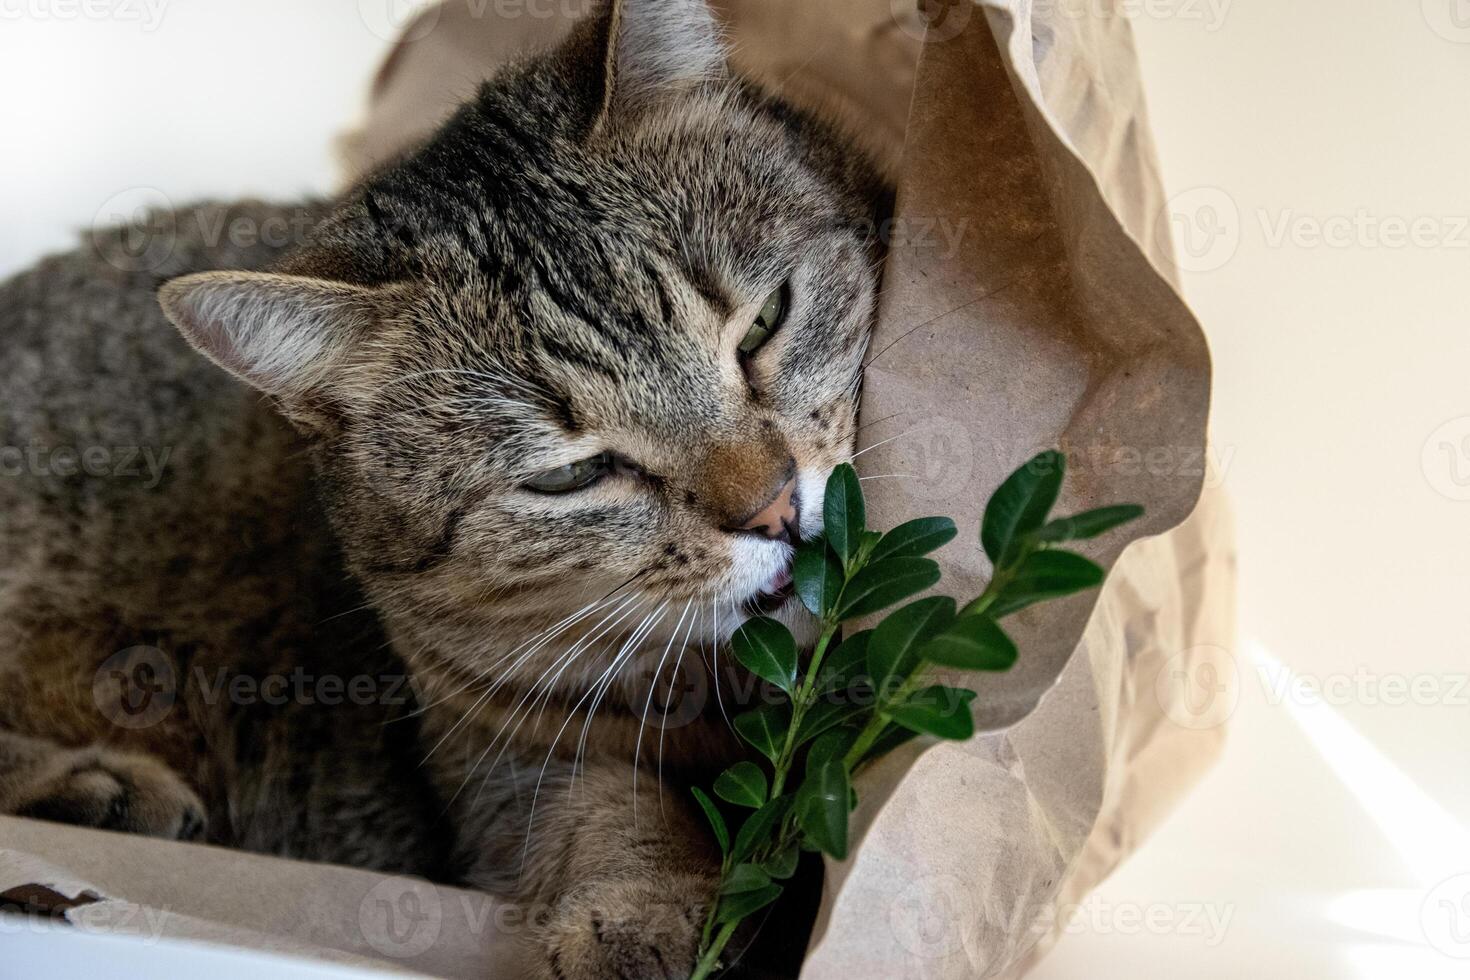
[159,272,378,404]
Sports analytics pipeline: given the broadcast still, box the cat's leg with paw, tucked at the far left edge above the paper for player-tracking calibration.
[0,732,204,840]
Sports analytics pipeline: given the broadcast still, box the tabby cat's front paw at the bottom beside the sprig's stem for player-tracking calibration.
[544,874,717,980]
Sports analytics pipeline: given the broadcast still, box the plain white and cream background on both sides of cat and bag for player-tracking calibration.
[0,0,1470,980]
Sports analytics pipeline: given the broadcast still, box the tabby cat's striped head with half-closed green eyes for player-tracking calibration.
[160,0,886,702]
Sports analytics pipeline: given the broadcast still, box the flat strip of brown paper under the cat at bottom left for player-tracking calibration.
[0,817,526,980]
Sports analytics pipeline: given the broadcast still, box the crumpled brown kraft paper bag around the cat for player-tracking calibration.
[0,0,1233,980]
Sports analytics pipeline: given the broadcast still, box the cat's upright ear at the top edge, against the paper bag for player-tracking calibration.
[569,0,728,128]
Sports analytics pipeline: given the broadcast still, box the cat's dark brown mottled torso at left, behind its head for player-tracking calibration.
[0,204,447,874]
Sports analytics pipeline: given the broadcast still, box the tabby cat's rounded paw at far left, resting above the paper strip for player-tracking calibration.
[15,749,204,840]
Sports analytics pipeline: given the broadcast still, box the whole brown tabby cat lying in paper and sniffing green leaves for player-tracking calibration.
[0,0,885,980]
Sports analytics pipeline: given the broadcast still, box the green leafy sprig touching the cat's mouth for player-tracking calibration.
[692,451,1144,980]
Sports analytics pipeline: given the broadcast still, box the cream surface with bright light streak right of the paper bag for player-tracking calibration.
[1036,0,1470,980]
